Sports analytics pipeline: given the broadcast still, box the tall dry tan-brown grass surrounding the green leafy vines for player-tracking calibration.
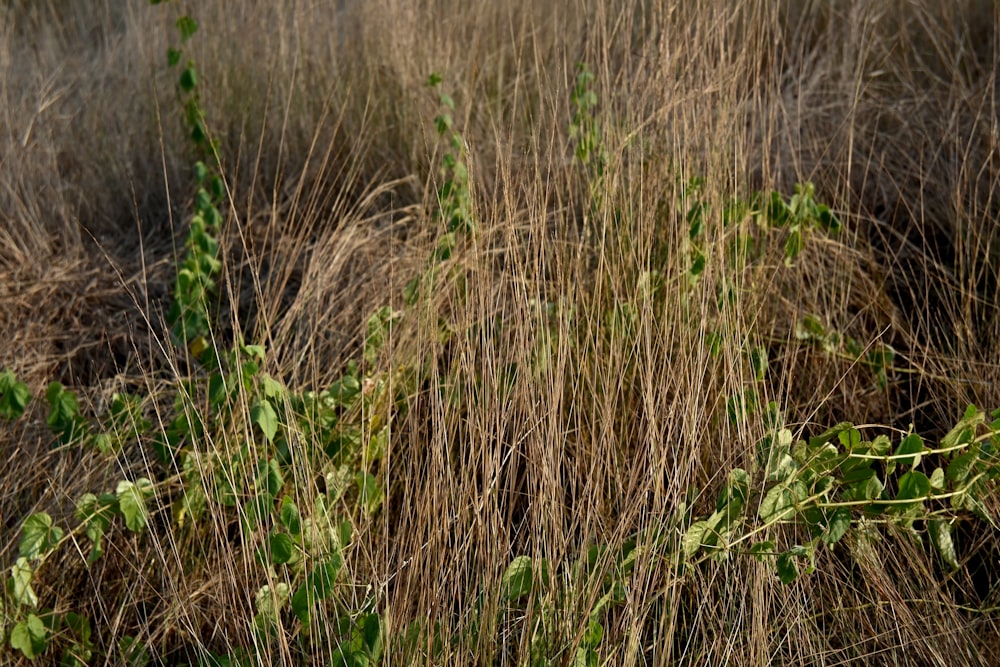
[0,0,1000,665]
